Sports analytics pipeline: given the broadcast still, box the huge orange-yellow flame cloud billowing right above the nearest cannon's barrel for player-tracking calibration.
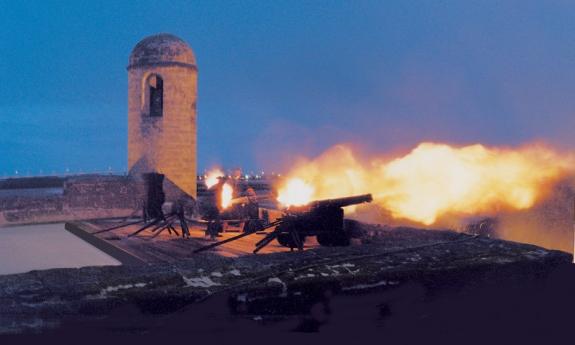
[278,143,575,225]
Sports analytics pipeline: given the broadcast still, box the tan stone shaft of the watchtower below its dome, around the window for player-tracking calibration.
[128,65,197,198]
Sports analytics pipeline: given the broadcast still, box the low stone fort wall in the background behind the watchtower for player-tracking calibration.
[0,175,271,226]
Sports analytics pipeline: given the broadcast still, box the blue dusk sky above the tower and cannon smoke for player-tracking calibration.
[0,0,575,177]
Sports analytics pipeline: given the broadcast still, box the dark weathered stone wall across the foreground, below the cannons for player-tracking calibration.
[0,226,575,336]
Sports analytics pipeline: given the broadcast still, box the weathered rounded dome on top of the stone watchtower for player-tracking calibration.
[128,33,196,69]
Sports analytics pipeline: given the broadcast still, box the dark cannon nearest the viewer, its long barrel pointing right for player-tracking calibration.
[194,194,373,254]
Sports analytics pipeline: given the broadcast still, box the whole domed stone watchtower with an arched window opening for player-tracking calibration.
[128,34,198,198]
